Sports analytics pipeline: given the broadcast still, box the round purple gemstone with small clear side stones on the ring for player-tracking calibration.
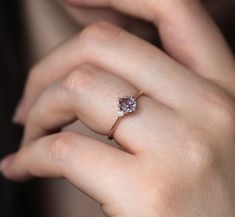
[118,96,136,116]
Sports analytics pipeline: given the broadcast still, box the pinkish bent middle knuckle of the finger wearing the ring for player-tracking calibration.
[62,65,97,94]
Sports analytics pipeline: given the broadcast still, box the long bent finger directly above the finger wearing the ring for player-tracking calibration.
[15,23,211,124]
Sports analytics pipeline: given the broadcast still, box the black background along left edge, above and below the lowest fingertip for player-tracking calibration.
[0,0,42,217]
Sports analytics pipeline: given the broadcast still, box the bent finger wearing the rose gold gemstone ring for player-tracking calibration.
[23,66,174,153]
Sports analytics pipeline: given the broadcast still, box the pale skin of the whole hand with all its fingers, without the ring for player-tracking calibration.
[1,0,235,217]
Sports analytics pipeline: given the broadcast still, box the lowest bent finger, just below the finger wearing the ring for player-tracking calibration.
[1,132,135,202]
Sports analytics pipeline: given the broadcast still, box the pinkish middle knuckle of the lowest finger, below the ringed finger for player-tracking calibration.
[49,132,76,161]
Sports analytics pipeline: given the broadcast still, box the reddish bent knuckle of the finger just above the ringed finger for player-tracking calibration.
[79,21,123,44]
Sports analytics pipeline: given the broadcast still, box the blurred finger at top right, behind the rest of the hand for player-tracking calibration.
[66,0,235,90]
